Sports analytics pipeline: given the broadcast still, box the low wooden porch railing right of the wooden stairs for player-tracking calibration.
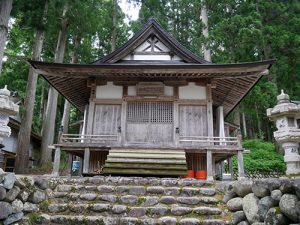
[179,136,240,147]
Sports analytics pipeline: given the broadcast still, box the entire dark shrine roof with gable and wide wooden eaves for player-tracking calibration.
[29,18,274,115]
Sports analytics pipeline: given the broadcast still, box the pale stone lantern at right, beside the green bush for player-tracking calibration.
[267,90,300,175]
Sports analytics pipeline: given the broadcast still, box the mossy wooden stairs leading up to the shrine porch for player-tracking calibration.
[103,149,187,176]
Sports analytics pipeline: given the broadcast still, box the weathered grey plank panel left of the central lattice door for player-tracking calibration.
[93,105,121,141]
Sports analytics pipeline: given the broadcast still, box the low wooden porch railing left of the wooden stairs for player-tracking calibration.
[60,134,119,143]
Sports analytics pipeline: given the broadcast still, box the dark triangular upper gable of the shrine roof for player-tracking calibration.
[92,18,211,65]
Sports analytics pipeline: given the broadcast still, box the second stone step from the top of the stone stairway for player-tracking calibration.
[54,184,216,196]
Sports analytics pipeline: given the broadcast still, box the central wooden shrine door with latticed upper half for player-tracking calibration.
[126,101,173,147]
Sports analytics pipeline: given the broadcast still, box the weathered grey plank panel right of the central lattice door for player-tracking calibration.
[179,105,207,145]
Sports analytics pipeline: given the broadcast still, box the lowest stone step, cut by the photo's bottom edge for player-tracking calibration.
[29,214,227,225]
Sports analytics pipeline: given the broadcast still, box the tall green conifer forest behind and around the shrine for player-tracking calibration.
[0,0,300,172]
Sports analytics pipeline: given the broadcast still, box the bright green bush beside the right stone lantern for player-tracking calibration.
[233,139,286,172]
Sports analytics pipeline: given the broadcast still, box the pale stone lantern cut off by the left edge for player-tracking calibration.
[0,85,19,148]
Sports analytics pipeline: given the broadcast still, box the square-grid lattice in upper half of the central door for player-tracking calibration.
[127,102,173,123]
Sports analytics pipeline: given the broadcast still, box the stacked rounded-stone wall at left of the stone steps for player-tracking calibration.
[0,169,52,225]
